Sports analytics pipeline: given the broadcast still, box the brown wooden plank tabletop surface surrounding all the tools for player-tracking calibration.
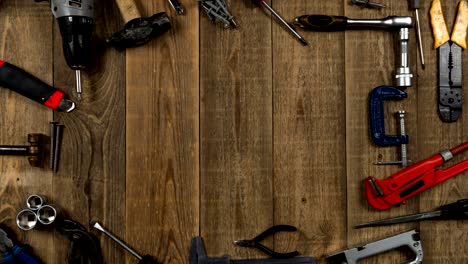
[0,0,468,264]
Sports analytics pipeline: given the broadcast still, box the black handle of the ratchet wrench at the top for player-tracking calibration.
[294,15,348,32]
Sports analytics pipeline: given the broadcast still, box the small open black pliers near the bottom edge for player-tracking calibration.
[234,225,299,259]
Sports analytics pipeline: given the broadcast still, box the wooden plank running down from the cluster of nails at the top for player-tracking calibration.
[200,1,273,259]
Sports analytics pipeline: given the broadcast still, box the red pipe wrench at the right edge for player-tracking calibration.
[365,141,468,210]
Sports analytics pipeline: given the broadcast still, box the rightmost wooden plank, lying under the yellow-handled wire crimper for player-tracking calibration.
[418,1,468,264]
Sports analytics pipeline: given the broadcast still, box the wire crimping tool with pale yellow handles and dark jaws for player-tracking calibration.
[430,0,468,122]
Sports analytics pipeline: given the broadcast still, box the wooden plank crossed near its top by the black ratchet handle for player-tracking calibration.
[273,1,346,263]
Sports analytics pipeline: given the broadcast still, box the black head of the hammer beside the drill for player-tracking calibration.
[107,12,172,49]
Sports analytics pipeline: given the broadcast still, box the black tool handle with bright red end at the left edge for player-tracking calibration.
[0,60,65,110]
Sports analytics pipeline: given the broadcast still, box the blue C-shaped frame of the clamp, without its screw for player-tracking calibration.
[369,86,409,147]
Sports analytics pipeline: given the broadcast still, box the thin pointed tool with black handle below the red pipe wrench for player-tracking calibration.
[356,199,468,228]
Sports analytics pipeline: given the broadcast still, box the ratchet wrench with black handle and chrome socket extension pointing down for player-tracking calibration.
[294,15,413,88]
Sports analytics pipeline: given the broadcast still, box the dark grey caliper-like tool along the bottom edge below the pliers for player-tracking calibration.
[189,237,316,264]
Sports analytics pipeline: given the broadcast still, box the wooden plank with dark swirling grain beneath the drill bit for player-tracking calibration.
[48,1,126,263]
